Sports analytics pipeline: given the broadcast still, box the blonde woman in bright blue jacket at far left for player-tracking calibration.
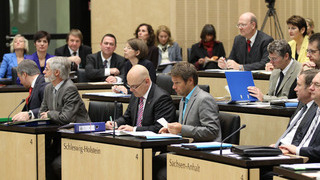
[0,34,29,78]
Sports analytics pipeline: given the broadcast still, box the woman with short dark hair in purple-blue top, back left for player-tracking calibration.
[26,31,53,74]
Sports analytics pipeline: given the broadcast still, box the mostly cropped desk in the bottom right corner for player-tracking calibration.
[273,166,320,180]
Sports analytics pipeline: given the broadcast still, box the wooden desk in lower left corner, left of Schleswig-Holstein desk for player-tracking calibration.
[0,125,57,180]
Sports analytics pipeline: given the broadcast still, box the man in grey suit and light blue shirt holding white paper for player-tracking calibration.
[159,62,221,141]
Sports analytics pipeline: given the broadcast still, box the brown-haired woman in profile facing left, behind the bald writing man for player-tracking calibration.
[112,38,156,94]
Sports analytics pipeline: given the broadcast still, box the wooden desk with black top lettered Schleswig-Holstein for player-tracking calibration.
[61,133,188,180]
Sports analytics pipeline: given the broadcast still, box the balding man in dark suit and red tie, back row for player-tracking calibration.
[218,12,273,71]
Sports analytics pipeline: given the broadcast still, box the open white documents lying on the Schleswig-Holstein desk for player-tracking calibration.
[99,130,182,139]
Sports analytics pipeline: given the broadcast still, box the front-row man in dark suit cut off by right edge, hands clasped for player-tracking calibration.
[276,70,320,162]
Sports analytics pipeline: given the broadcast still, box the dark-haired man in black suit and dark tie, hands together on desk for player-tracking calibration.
[86,34,125,83]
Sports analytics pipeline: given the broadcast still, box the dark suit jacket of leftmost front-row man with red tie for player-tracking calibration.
[22,74,47,118]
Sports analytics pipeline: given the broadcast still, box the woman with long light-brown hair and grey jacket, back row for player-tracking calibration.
[157,25,182,73]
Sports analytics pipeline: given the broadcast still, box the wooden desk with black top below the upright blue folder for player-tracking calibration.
[219,103,296,146]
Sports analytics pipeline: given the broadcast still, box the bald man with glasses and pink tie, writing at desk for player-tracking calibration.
[106,65,175,133]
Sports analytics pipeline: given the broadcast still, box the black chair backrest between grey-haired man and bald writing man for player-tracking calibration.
[88,101,122,122]
